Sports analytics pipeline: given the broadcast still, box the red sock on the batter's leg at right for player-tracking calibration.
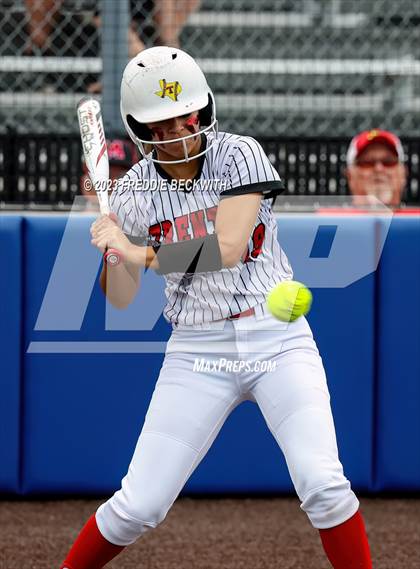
[319,512,372,569]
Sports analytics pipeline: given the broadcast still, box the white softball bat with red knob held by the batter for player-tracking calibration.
[77,97,122,266]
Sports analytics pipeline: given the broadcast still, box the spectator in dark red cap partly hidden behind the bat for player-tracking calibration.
[80,138,138,212]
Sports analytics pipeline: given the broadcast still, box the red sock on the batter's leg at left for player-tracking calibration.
[60,515,124,569]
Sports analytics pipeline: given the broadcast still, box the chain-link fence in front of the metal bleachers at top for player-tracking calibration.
[0,0,420,137]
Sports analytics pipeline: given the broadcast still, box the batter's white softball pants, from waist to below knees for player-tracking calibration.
[96,310,359,545]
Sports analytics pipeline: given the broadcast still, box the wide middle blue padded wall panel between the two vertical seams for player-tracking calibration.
[19,216,375,493]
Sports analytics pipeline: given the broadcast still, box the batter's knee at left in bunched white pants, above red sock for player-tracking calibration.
[96,491,168,545]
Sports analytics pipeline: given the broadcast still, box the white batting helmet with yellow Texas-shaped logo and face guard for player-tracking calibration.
[121,47,217,164]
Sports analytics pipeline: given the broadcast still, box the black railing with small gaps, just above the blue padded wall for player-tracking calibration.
[0,134,420,212]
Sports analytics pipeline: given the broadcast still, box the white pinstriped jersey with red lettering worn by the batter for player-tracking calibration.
[110,132,293,325]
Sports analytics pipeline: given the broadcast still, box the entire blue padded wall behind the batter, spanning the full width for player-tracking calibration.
[10,212,420,494]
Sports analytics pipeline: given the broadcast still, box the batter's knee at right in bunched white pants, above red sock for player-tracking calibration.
[301,476,359,529]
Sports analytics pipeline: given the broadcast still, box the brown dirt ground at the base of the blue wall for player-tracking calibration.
[0,498,420,569]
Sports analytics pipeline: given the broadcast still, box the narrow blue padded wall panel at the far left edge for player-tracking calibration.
[0,215,22,493]
